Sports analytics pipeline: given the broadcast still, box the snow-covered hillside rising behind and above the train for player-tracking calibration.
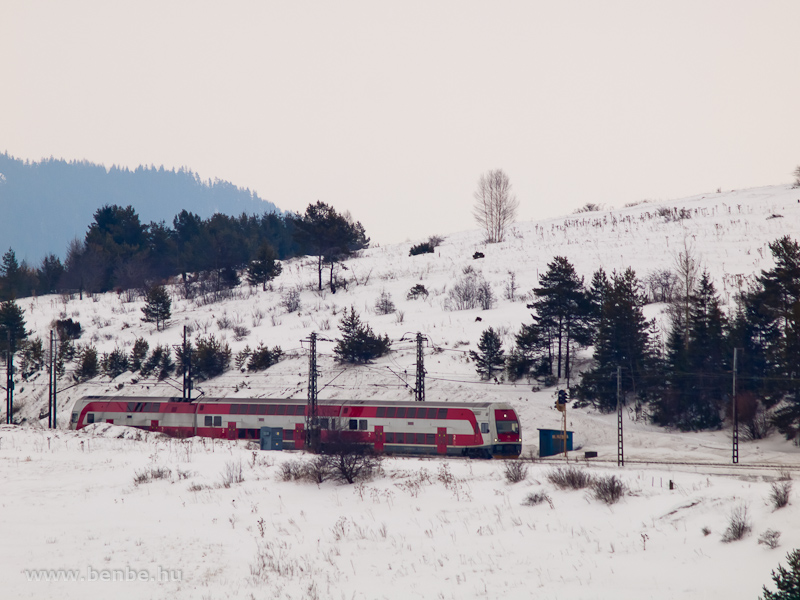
[16,186,800,458]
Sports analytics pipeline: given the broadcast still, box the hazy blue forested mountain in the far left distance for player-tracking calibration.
[0,153,281,266]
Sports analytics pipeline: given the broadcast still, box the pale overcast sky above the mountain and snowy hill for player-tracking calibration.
[0,0,800,243]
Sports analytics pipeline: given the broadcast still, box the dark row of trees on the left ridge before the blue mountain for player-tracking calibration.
[0,202,369,300]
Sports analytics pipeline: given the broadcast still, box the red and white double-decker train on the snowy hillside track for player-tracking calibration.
[70,396,522,458]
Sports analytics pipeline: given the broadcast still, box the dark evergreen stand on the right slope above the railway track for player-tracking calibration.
[471,236,800,439]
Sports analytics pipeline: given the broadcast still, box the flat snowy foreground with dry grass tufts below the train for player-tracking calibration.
[0,425,800,600]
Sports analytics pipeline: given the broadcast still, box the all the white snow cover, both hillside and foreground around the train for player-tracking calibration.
[0,186,800,599]
